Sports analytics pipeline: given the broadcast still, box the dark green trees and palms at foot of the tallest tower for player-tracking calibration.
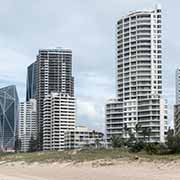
[110,124,180,155]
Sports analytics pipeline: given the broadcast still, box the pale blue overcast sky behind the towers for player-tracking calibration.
[0,0,180,130]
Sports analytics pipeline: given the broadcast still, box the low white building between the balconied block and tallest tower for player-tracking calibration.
[65,126,105,149]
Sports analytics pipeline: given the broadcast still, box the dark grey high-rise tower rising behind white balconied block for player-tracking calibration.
[27,48,74,149]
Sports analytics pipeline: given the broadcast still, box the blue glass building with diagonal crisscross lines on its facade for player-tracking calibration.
[0,85,19,151]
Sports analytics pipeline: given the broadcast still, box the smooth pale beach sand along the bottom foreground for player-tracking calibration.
[0,160,180,180]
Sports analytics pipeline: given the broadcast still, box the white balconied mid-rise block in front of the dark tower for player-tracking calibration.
[43,93,76,150]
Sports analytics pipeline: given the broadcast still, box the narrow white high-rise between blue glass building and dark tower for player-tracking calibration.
[19,99,37,152]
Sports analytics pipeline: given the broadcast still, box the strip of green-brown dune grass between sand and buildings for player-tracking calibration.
[0,149,180,163]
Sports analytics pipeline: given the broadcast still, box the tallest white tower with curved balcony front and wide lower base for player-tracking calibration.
[106,6,167,142]
